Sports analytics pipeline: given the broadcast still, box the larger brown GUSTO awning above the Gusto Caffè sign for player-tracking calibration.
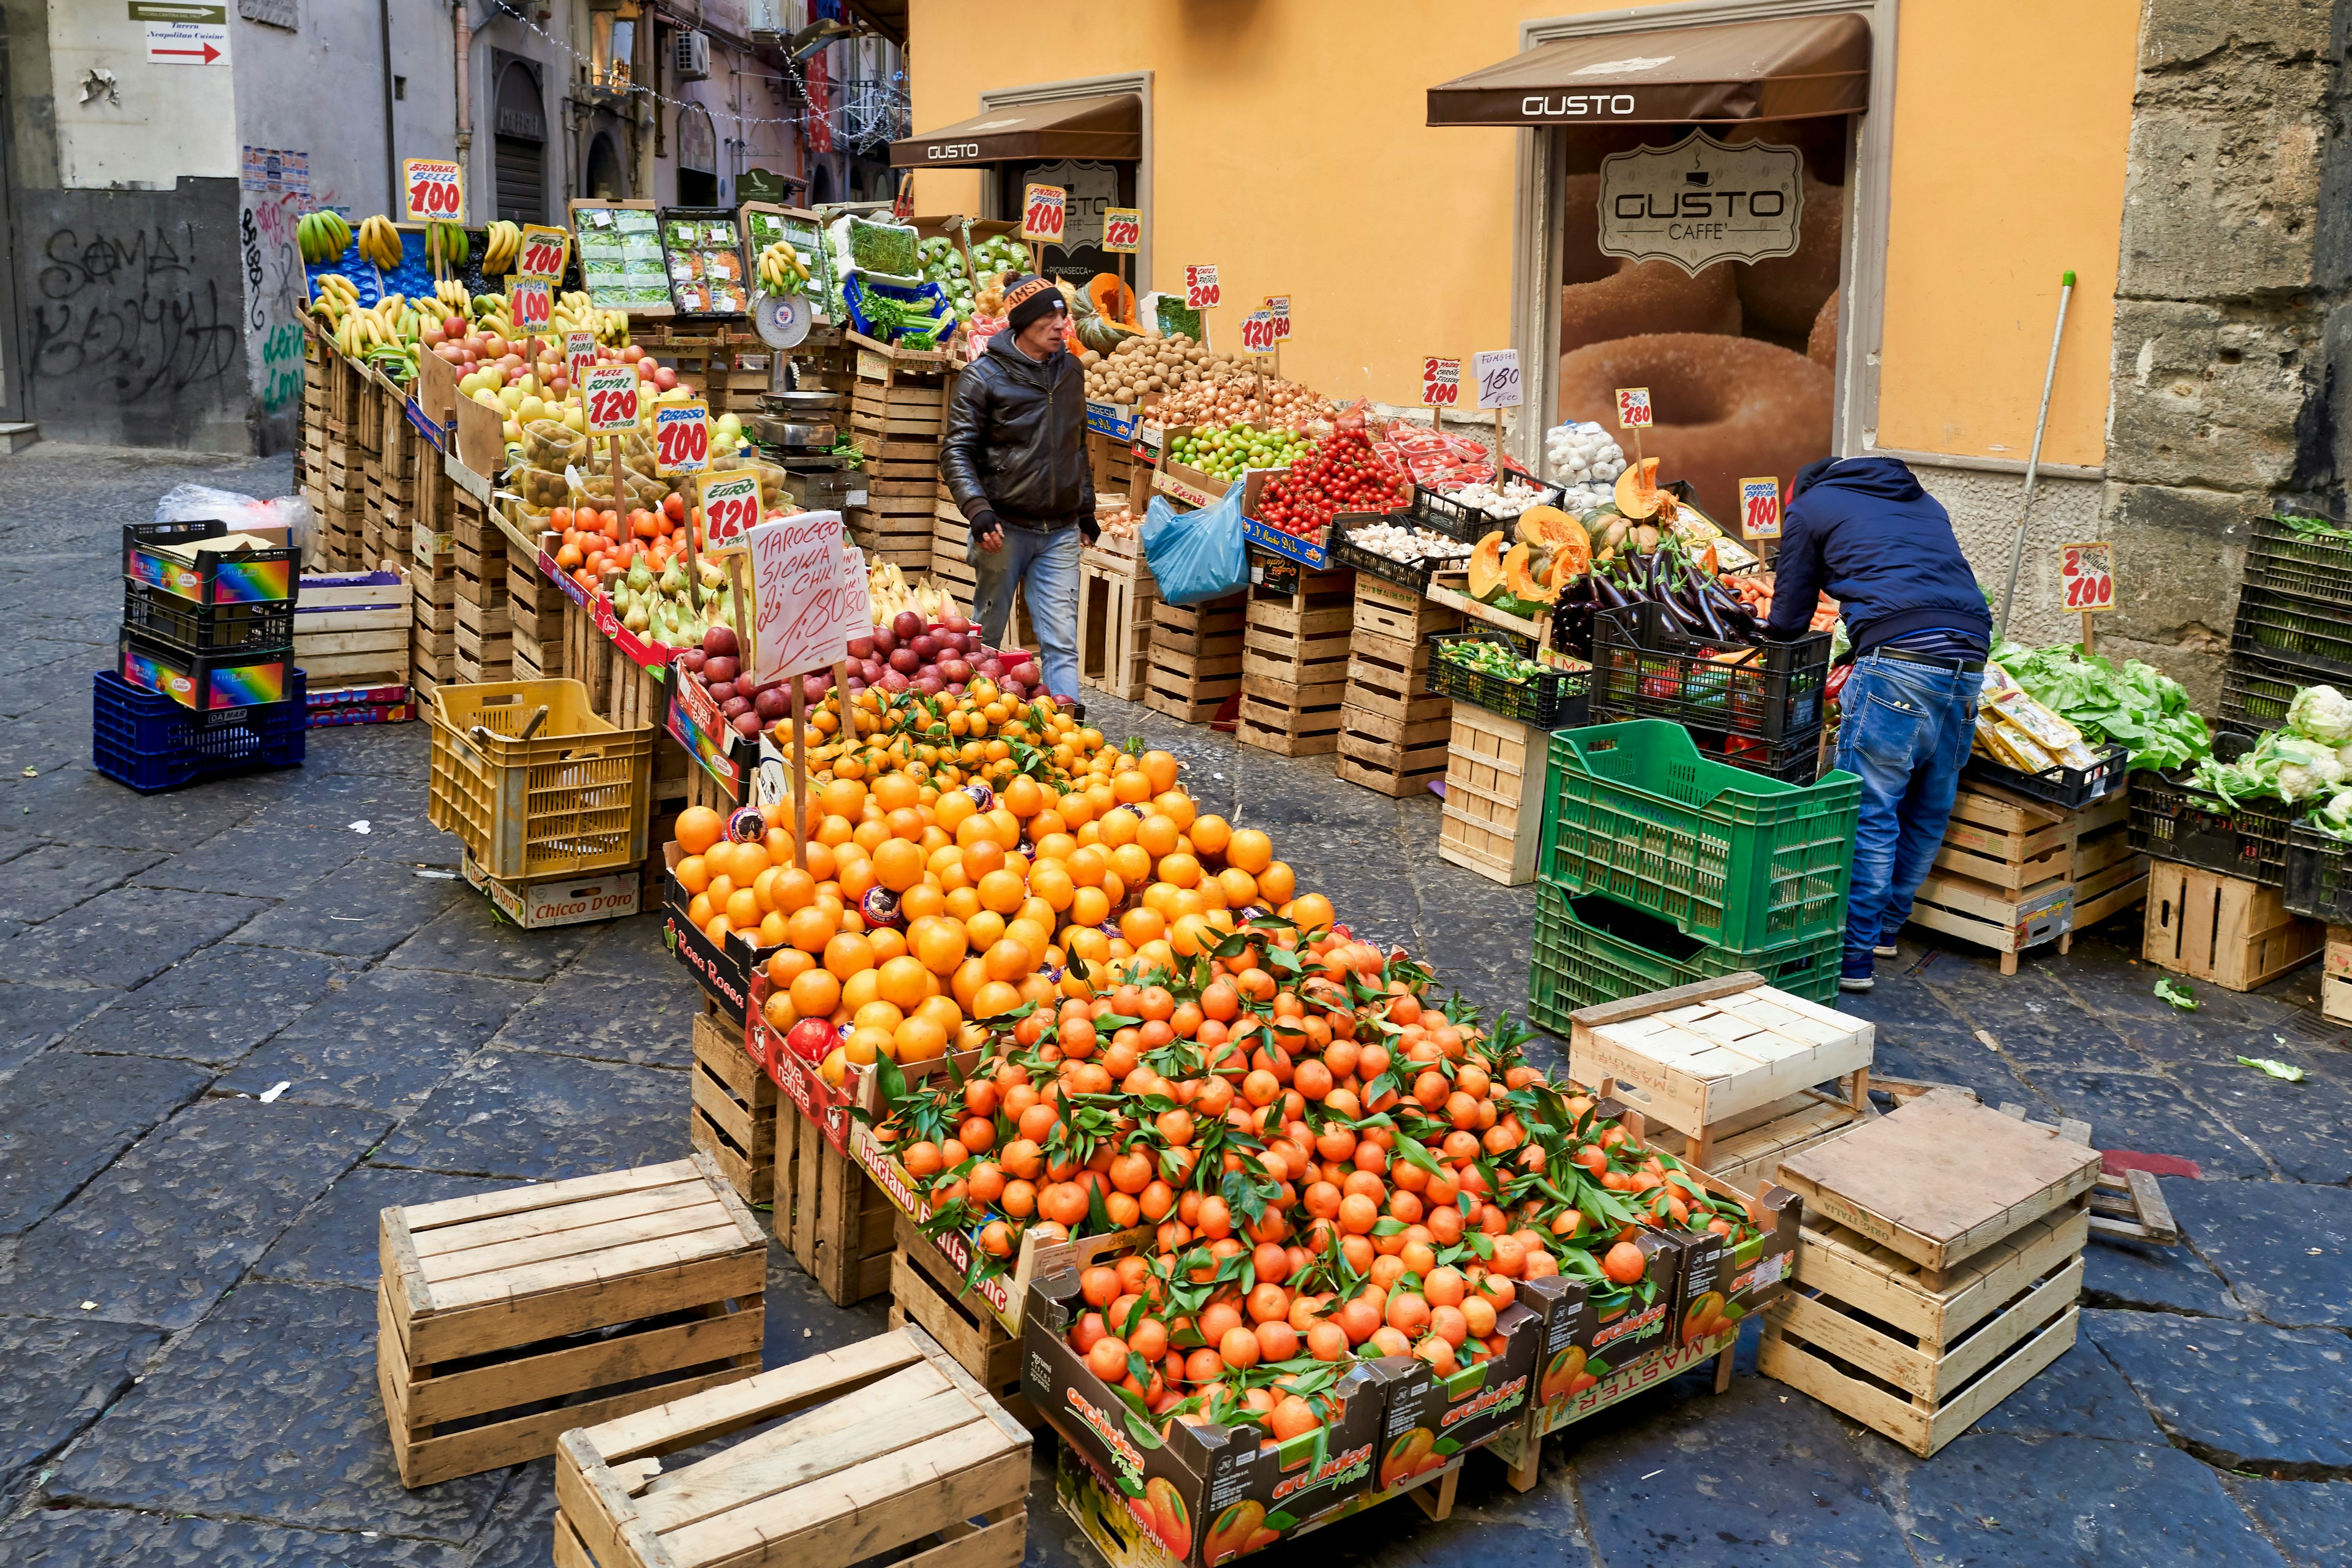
[1430,14,1870,124]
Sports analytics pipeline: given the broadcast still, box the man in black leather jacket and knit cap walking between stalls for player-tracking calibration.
[938,277,1094,701]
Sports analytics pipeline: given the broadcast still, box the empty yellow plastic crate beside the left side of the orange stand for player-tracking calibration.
[426,679,654,881]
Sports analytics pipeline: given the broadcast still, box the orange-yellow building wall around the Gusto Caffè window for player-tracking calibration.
[908,0,2138,463]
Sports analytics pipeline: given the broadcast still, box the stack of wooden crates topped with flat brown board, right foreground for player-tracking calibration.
[1757,1088,2100,1458]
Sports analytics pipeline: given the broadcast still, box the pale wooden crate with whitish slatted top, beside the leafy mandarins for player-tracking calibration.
[1569,973,1877,1170]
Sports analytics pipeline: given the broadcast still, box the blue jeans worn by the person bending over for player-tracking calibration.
[1837,654,1983,976]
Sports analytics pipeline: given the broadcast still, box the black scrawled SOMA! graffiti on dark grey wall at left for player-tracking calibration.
[26,221,240,404]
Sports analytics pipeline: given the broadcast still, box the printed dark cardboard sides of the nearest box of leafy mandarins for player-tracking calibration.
[1021,1267,1388,1568]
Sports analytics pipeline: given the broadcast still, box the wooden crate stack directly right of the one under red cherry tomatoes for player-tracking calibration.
[1336,573,1463,794]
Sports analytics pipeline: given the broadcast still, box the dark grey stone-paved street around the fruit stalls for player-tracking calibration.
[0,447,2352,1568]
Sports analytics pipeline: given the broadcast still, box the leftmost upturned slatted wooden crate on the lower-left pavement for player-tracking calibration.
[376,1154,767,1486]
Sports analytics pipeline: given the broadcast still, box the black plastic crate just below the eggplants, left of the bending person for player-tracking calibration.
[1593,600,1830,741]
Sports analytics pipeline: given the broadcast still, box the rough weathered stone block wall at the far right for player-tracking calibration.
[2100,0,2352,712]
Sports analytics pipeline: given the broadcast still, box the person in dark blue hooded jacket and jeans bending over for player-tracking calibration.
[1764,458,1992,992]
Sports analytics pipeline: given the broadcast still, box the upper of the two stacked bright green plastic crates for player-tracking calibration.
[1536,719,1863,948]
